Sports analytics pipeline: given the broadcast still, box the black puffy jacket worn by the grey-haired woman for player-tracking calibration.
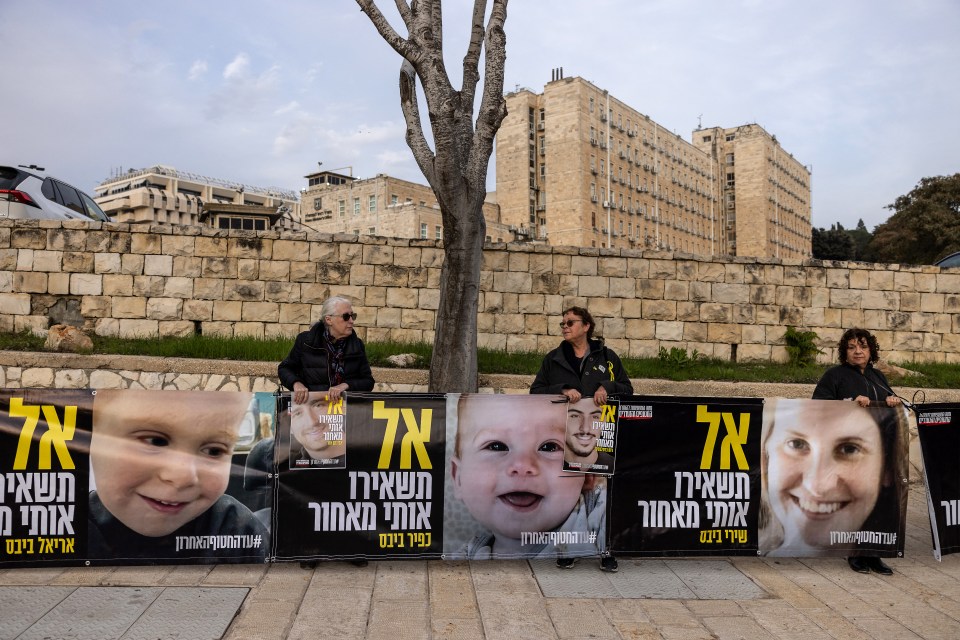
[277,322,373,391]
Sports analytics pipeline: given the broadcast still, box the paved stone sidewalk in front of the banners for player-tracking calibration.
[0,485,960,640]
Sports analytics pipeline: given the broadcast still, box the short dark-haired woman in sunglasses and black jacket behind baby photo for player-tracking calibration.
[530,307,633,573]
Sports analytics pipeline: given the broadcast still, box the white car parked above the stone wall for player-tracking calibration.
[0,164,110,222]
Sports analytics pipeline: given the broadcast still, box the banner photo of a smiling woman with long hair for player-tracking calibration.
[759,398,907,557]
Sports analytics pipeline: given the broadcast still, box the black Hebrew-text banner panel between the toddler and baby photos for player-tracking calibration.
[273,392,446,560]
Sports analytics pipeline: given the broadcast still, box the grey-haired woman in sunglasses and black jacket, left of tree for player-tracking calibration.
[277,296,373,404]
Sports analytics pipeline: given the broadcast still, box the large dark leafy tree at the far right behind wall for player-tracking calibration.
[865,173,960,264]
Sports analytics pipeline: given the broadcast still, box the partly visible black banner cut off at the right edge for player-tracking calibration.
[916,403,960,560]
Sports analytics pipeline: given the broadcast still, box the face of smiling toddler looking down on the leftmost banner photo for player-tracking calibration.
[90,389,253,537]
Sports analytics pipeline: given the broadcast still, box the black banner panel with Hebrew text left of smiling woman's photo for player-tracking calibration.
[610,396,763,556]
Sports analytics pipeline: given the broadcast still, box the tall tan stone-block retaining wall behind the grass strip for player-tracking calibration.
[0,221,960,362]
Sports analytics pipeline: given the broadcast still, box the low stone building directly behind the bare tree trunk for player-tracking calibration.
[301,171,514,242]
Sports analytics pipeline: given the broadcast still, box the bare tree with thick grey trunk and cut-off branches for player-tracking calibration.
[357,0,507,392]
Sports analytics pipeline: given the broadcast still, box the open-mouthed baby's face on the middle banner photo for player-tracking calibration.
[451,395,584,539]
